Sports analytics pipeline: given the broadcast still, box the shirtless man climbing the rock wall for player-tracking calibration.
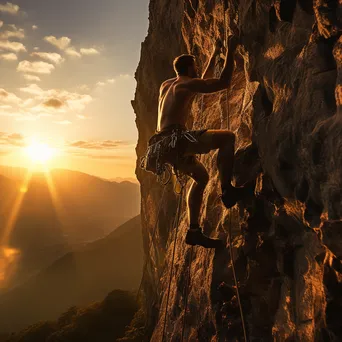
[145,37,251,248]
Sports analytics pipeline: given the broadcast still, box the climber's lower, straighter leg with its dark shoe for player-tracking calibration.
[177,156,223,248]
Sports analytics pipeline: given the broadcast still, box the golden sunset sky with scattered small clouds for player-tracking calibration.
[0,0,148,179]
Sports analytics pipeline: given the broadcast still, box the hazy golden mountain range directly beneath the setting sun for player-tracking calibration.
[0,166,140,293]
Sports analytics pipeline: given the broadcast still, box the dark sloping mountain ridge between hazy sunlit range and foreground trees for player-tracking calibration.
[0,216,143,332]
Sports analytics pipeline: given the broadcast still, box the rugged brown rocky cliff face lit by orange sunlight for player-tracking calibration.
[133,0,342,341]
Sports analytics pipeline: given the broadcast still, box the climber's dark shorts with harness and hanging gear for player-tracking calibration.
[141,125,207,176]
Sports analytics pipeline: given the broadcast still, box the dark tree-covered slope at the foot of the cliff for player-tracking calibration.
[7,290,138,342]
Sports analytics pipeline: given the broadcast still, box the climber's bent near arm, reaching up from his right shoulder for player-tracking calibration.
[178,37,238,93]
